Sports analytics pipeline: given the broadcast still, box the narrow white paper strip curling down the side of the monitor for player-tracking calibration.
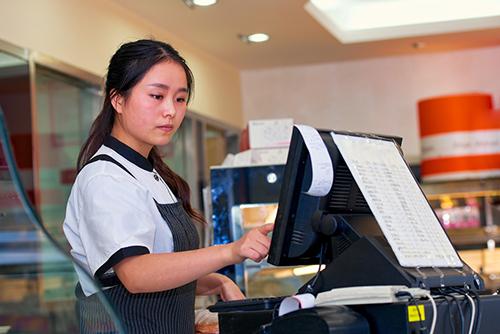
[295,124,333,196]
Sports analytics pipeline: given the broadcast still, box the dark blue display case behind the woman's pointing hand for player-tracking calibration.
[210,165,318,297]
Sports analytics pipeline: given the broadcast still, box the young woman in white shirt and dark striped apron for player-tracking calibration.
[64,40,272,334]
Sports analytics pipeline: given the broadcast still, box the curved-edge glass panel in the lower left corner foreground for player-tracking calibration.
[0,110,123,333]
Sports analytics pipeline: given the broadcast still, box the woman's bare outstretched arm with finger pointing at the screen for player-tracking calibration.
[113,224,273,293]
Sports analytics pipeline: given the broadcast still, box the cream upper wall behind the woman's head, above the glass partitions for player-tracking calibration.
[0,0,243,127]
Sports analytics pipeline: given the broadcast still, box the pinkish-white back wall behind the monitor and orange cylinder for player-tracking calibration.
[242,47,500,162]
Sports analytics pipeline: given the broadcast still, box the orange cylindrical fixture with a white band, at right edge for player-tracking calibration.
[418,93,500,181]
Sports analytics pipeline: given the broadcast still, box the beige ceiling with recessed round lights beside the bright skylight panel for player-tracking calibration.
[112,0,500,70]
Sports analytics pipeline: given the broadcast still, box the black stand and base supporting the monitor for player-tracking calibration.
[299,216,484,295]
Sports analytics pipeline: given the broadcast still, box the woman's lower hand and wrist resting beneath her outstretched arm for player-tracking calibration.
[196,273,245,301]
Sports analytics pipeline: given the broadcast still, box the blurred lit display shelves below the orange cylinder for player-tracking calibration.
[422,178,500,291]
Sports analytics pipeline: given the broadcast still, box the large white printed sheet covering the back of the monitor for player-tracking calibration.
[332,132,463,267]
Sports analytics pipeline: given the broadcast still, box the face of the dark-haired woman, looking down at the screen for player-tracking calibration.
[111,61,188,157]
